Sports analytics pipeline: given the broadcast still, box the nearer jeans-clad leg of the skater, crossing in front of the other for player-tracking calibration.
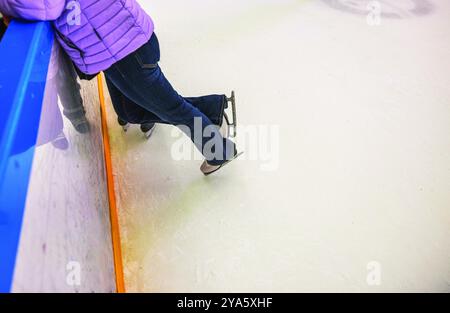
[105,36,236,165]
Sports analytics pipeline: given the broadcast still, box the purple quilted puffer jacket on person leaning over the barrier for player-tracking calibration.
[0,0,154,74]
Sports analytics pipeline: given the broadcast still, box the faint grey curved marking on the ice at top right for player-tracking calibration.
[322,0,434,19]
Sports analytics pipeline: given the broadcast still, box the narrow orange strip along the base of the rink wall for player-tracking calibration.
[97,74,125,293]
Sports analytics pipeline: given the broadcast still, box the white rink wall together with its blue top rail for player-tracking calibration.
[0,21,116,292]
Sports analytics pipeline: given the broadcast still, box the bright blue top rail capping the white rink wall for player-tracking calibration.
[0,21,53,292]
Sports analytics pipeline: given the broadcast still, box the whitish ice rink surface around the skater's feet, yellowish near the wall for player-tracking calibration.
[104,0,450,292]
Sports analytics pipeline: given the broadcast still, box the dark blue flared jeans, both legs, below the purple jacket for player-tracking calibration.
[105,34,235,165]
